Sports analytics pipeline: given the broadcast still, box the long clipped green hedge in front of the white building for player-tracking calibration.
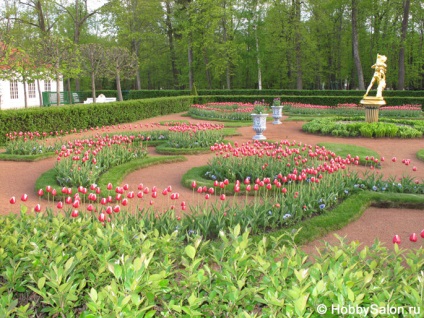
[0,96,193,144]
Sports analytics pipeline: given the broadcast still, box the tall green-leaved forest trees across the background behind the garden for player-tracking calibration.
[0,0,424,91]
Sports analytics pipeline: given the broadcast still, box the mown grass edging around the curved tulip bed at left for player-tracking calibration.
[34,156,187,200]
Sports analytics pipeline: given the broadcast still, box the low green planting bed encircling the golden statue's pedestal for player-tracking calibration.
[302,117,424,138]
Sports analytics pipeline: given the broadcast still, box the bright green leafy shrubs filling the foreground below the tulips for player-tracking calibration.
[0,213,424,317]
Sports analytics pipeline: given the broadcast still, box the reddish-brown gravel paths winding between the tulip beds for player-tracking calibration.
[0,114,424,252]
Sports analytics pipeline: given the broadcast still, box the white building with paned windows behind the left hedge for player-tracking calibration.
[0,80,63,109]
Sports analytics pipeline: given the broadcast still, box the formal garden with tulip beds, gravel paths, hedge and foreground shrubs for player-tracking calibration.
[0,96,424,317]
